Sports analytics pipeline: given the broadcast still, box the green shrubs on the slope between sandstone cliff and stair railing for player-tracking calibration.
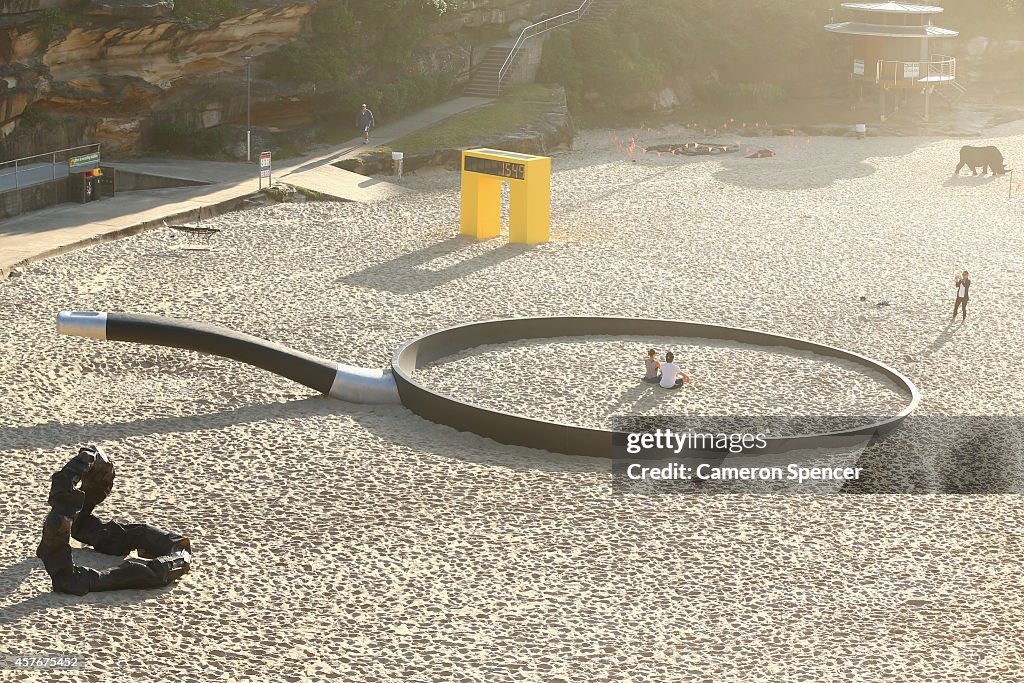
[260,0,450,84]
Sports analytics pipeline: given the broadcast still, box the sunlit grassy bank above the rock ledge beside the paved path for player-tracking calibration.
[387,84,555,155]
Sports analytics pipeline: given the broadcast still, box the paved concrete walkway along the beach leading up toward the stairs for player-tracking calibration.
[0,97,494,280]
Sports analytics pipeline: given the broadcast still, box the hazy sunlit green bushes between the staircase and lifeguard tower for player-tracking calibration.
[538,0,829,112]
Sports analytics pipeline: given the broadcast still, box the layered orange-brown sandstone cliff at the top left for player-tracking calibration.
[0,0,312,155]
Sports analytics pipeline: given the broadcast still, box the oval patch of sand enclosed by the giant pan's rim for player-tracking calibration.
[415,337,909,429]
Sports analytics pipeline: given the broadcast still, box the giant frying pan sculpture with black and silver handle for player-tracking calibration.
[57,311,921,457]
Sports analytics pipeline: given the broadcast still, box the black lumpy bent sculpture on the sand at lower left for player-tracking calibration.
[36,444,191,595]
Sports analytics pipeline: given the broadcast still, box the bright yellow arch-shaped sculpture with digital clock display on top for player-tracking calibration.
[460,150,551,245]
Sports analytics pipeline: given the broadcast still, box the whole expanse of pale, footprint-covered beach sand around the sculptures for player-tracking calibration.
[0,123,1024,683]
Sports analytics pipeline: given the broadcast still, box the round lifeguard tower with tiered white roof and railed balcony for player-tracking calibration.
[825,2,964,121]
